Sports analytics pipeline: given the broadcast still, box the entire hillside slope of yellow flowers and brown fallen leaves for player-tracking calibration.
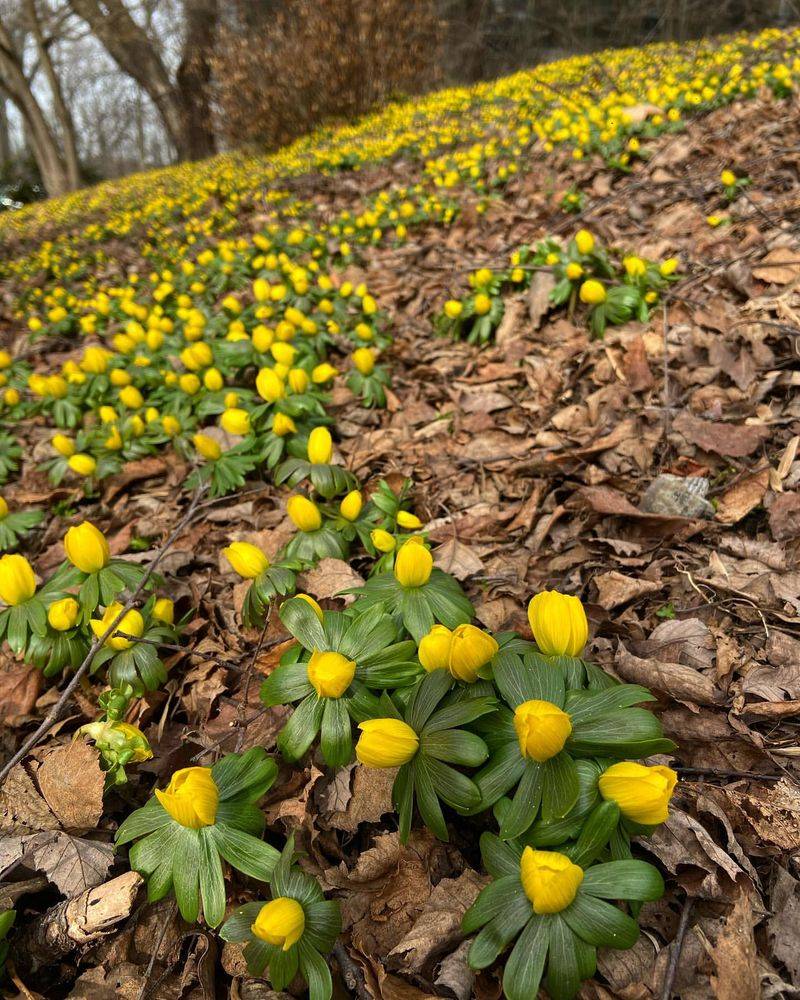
[0,23,800,1000]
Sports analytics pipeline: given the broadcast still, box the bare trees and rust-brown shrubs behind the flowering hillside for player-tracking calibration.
[0,0,800,208]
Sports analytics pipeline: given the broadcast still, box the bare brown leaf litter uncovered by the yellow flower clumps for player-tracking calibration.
[0,82,800,1000]
